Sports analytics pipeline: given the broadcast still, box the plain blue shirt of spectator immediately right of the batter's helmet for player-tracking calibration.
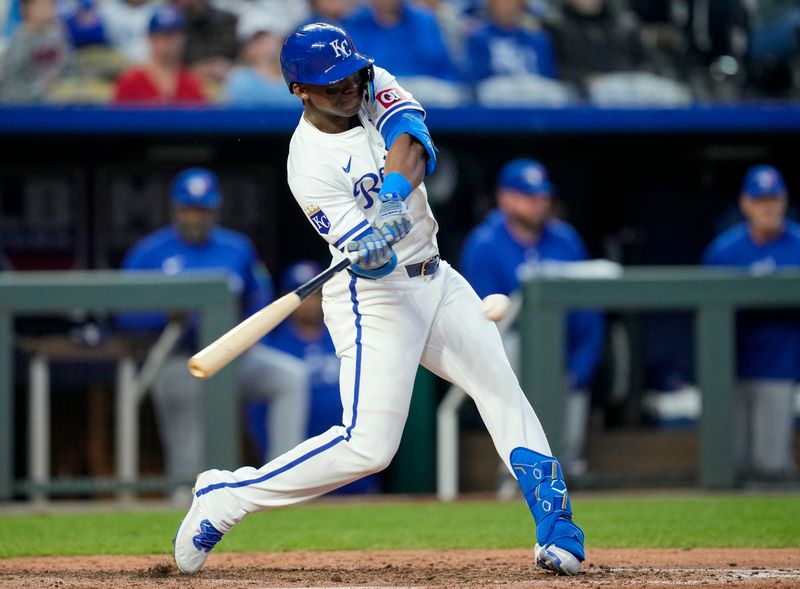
[342,2,458,81]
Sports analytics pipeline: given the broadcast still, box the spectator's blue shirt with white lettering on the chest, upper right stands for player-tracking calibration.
[466,23,558,83]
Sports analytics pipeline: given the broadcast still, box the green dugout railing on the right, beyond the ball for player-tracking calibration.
[437,267,800,500]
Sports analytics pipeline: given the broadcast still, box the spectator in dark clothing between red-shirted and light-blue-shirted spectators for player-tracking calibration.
[173,0,239,99]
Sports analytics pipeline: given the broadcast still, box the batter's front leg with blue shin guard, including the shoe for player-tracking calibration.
[422,264,584,574]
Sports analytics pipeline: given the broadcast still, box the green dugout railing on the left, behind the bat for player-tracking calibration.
[0,270,240,501]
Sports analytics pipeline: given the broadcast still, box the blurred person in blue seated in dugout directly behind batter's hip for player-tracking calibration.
[250,260,380,493]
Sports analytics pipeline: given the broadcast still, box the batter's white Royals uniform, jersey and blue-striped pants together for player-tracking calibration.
[195,68,550,532]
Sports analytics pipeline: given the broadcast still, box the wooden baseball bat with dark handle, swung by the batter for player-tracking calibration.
[188,252,358,379]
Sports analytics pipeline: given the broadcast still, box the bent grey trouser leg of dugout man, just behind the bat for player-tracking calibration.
[239,344,310,461]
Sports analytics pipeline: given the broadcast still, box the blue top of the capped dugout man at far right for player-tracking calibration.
[703,221,800,380]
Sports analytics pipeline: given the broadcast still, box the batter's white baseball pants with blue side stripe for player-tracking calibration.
[195,262,550,533]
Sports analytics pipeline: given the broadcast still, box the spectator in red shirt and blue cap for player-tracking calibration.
[114,4,207,104]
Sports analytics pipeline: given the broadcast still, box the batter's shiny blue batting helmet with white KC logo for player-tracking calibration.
[281,23,375,91]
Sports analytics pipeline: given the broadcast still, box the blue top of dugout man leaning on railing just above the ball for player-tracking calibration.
[461,210,604,388]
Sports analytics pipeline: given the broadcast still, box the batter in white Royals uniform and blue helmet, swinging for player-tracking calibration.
[174,24,584,574]
